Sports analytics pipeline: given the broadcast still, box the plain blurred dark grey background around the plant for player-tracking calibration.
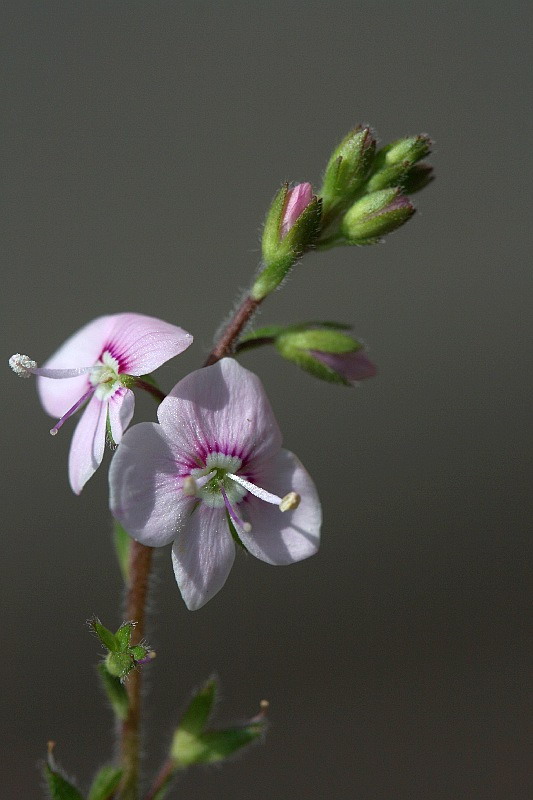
[0,0,533,800]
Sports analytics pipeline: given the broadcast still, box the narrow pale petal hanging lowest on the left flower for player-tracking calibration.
[68,395,107,494]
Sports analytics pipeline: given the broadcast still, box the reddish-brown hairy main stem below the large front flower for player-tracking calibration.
[119,541,153,800]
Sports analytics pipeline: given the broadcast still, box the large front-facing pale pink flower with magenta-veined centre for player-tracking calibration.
[109,358,321,610]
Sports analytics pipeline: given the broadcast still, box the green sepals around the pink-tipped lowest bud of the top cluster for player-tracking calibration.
[250,195,322,300]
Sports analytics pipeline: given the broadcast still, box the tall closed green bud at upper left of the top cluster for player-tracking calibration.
[320,126,376,222]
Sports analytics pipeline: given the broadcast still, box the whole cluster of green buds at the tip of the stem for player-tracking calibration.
[251,126,433,301]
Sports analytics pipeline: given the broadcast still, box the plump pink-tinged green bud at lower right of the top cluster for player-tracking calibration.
[341,187,415,245]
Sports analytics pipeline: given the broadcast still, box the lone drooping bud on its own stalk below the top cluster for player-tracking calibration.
[275,327,377,386]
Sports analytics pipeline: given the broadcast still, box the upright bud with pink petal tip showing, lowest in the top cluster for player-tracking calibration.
[251,183,322,300]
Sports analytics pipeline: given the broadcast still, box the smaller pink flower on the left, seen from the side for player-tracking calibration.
[9,313,192,494]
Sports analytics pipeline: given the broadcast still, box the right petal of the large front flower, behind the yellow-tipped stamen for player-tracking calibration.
[238,450,322,564]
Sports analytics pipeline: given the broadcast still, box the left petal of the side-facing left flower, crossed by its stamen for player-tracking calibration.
[37,315,114,417]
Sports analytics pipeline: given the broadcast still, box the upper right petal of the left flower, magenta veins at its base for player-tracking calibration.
[106,313,193,375]
